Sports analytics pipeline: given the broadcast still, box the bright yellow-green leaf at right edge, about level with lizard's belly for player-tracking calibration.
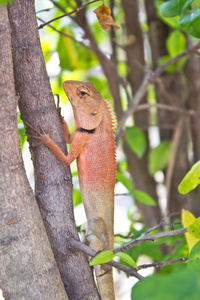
[178,161,200,195]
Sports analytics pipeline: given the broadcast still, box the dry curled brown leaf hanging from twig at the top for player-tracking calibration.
[93,4,120,32]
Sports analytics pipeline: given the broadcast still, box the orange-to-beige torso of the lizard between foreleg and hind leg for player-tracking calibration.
[77,139,116,249]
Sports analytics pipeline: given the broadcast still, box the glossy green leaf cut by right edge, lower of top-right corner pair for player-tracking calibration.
[179,8,200,38]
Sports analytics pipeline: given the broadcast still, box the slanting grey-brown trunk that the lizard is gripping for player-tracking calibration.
[9,0,99,300]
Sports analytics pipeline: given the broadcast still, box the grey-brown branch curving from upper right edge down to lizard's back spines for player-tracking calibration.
[116,43,200,143]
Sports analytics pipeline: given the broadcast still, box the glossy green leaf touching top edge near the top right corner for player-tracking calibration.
[159,0,194,18]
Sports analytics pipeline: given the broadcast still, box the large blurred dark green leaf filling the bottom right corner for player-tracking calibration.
[131,269,200,300]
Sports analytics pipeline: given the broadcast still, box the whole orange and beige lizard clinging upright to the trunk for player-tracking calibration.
[27,80,116,300]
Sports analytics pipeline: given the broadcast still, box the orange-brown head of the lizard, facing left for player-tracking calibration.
[63,80,104,130]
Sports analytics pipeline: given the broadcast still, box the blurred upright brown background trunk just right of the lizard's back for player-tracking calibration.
[122,0,161,226]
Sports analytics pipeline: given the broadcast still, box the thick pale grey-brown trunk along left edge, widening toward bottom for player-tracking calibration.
[0,7,68,300]
